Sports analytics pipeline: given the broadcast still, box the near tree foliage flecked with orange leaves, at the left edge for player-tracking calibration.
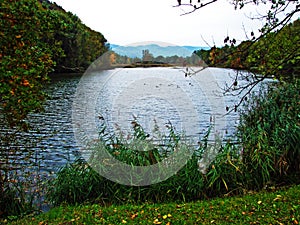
[0,0,54,126]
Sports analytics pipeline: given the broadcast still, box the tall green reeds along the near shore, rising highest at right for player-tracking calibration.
[50,80,300,205]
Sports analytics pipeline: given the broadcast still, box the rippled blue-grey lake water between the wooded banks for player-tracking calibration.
[0,68,262,209]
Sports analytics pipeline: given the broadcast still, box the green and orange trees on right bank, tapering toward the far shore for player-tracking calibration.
[196,19,300,80]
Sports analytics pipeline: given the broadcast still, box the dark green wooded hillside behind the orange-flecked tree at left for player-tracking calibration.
[39,0,108,72]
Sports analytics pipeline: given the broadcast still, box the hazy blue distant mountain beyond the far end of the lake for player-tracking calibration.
[110,44,209,58]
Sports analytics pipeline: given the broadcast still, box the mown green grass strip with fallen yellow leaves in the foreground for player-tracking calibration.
[2,185,300,225]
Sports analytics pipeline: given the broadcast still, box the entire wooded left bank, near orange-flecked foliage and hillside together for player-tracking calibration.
[0,0,107,125]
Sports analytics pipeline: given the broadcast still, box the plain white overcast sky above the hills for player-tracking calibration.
[52,0,270,46]
